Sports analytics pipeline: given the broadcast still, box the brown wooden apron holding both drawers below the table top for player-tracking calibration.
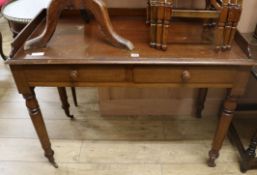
[12,65,246,88]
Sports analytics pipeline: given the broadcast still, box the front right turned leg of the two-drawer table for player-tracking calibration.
[208,95,237,167]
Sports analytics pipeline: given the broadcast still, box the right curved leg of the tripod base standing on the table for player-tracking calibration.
[82,0,134,50]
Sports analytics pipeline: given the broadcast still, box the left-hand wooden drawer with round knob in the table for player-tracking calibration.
[26,66,126,82]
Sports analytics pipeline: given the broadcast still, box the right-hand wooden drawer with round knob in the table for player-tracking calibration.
[134,66,237,84]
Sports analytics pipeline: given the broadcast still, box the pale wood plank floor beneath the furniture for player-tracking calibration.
[0,16,256,175]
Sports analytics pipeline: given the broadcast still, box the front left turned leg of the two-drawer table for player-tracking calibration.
[23,89,58,168]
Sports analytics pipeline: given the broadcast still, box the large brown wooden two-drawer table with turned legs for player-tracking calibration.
[8,12,255,166]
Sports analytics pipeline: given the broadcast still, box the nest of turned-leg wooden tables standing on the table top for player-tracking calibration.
[148,0,242,50]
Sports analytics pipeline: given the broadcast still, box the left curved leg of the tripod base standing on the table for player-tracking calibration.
[25,0,68,49]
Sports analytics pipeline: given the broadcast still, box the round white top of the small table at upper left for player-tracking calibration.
[2,0,51,23]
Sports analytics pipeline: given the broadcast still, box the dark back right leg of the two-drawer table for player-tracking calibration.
[196,88,208,118]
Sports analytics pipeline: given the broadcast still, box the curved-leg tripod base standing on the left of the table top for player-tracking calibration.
[25,0,134,50]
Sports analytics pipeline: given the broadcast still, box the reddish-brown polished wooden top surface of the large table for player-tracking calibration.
[8,14,254,66]
